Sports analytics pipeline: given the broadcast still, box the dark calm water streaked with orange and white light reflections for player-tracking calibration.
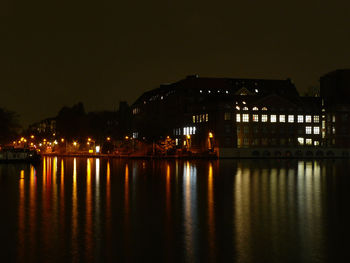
[0,158,350,262]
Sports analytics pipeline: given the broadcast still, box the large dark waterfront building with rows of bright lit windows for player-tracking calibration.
[132,76,323,156]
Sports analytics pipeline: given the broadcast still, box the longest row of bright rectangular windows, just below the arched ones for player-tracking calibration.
[237,113,320,123]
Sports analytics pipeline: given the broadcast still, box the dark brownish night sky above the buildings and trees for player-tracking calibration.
[0,0,350,125]
